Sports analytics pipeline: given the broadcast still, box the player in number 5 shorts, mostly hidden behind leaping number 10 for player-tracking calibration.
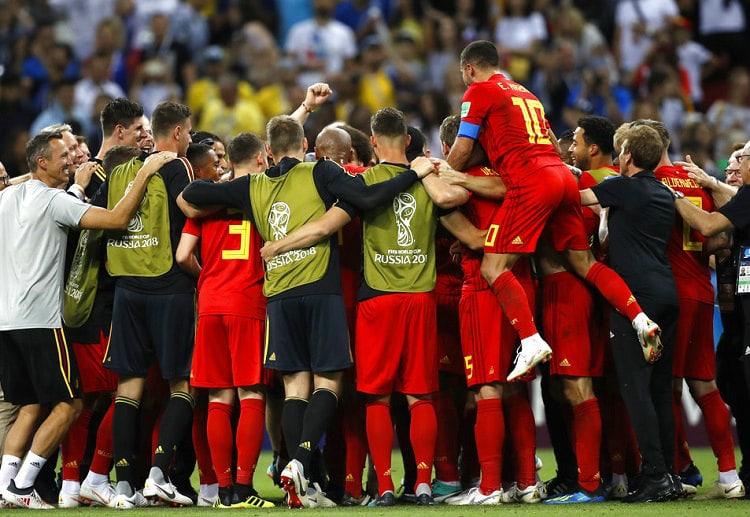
[440,116,542,505]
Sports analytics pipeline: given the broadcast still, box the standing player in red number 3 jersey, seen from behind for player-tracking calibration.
[176,133,273,508]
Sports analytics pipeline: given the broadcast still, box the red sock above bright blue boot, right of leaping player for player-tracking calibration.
[573,398,602,492]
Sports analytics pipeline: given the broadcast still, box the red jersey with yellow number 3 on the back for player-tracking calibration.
[182,209,266,320]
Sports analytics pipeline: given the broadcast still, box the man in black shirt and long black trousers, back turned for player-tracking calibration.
[581,126,682,502]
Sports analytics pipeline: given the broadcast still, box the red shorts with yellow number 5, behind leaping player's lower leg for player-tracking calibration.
[459,289,518,387]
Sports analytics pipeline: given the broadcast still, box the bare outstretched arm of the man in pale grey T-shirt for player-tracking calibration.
[80,151,177,230]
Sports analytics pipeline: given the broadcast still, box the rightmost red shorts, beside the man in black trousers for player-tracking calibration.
[672,298,716,381]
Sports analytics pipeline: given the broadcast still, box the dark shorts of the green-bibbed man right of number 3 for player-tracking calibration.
[263,294,352,372]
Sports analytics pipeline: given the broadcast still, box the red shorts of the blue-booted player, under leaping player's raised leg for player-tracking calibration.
[542,272,604,377]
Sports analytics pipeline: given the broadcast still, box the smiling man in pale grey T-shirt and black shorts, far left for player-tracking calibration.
[0,132,173,509]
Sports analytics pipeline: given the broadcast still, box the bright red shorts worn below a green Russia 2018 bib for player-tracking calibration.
[355,293,438,395]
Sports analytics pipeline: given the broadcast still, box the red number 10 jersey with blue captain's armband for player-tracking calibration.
[458,74,563,188]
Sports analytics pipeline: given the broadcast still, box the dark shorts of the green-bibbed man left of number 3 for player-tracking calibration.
[104,287,195,380]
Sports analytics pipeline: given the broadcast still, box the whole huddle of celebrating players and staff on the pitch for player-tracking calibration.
[0,41,750,509]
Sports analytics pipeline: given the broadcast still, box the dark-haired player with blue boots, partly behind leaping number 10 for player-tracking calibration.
[539,116,627,504]
